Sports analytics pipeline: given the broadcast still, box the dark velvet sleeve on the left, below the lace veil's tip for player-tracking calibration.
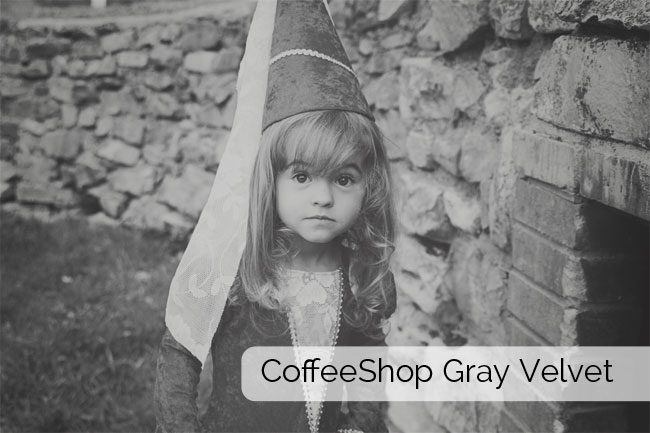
[154,329,201,433]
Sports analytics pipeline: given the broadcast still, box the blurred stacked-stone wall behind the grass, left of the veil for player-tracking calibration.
[1,8,250,234]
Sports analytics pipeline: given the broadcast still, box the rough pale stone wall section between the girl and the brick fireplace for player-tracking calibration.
[330,1,528,432]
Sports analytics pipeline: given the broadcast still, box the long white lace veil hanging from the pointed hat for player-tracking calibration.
[165,0,277,364]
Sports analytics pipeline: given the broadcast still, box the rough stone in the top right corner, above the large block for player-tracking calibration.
[554,0,650,30]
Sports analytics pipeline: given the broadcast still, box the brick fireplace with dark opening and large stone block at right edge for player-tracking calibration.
[502,1,650,432]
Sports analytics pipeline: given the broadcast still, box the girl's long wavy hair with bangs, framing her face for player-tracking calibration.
[231,110,395,335]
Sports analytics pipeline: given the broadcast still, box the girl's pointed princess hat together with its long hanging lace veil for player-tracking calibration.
[165,0,374,363]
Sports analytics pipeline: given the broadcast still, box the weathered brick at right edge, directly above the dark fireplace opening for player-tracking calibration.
[580,145,650,220]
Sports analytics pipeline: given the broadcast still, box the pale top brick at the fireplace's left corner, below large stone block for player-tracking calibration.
[514,130,582,191]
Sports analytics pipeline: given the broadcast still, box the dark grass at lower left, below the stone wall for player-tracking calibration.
[0,214,184,432]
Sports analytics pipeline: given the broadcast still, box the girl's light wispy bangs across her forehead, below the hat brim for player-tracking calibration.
[269,110,378,176]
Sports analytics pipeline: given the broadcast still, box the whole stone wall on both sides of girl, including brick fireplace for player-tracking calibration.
[1,0,650,432]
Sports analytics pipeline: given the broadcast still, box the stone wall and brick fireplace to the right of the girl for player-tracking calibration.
[330,0,650,432]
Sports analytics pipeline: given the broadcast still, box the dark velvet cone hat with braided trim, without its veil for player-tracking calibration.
[263,0,374,129]
